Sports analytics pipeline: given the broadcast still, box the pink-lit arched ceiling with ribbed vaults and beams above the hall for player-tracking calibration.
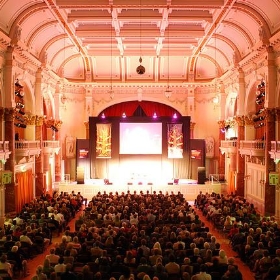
[0,0,280,84]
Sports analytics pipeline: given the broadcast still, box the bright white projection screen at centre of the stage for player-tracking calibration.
[119,122,162,155]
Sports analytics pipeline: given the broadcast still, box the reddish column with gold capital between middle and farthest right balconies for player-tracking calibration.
[235,116,245,196]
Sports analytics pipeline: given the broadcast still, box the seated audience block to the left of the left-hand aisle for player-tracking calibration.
[0,189,83,279]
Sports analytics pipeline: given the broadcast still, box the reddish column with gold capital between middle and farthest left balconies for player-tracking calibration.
[35,116,46,196]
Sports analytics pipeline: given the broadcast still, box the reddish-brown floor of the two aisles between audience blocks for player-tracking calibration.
[24,205,254,280]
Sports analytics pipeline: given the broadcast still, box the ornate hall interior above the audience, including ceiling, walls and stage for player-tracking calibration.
[0,0,280,279]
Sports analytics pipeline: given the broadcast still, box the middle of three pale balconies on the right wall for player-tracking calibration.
[239,140,265,157]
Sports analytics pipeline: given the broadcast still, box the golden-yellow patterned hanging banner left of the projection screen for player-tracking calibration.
[96,123,112,158]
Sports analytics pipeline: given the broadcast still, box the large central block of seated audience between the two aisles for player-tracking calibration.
[25,191,249,280]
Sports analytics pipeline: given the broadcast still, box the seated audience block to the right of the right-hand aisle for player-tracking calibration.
[195,193,280,280]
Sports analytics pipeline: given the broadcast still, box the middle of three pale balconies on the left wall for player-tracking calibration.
[15,140,41,157]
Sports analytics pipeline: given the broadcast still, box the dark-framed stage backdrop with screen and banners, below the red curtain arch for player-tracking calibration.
[89,116,190,184]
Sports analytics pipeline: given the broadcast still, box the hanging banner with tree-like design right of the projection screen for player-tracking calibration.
[167,123,183,158]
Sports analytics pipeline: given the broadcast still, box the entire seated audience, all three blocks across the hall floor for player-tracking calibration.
[0,191,280,280]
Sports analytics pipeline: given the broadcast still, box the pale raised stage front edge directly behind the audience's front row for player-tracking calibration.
[55,179,222,201]
